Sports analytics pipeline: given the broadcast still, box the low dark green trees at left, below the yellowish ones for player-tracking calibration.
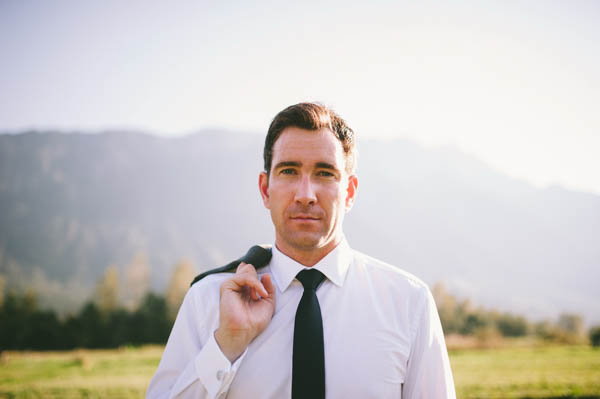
[0,293,173,350]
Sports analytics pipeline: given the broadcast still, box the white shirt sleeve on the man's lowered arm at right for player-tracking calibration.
[402,288,456,399]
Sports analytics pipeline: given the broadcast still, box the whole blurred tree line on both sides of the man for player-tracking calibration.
[0,276,600,350]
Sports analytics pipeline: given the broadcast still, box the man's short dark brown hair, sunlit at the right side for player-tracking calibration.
[263,103,356,174]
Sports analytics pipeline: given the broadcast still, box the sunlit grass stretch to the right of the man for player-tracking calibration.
[450,346,600,398]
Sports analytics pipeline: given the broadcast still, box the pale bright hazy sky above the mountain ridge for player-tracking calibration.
[0,0,600,194]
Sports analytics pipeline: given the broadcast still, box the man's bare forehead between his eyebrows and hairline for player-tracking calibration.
[272,127,344,170]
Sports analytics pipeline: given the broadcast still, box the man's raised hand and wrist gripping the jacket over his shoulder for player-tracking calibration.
[215,262,275,363]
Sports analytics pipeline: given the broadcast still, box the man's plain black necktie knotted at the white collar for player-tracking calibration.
[292,269,325,399]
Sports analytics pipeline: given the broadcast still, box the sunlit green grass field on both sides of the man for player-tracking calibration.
[0,346,600,399]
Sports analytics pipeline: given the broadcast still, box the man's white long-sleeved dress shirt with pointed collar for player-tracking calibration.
[147,240,455,399]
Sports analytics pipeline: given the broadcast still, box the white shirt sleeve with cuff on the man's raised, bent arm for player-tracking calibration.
[146,289,246,399]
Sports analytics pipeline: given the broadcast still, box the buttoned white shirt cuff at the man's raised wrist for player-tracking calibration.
[195,334,248,398]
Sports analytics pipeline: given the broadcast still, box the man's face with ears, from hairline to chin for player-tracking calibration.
[259,127,358,260]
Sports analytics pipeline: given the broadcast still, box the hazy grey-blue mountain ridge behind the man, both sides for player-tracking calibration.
[0,129,600,322]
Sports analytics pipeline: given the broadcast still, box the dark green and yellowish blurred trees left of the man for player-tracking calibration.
[0,255,196,351]
